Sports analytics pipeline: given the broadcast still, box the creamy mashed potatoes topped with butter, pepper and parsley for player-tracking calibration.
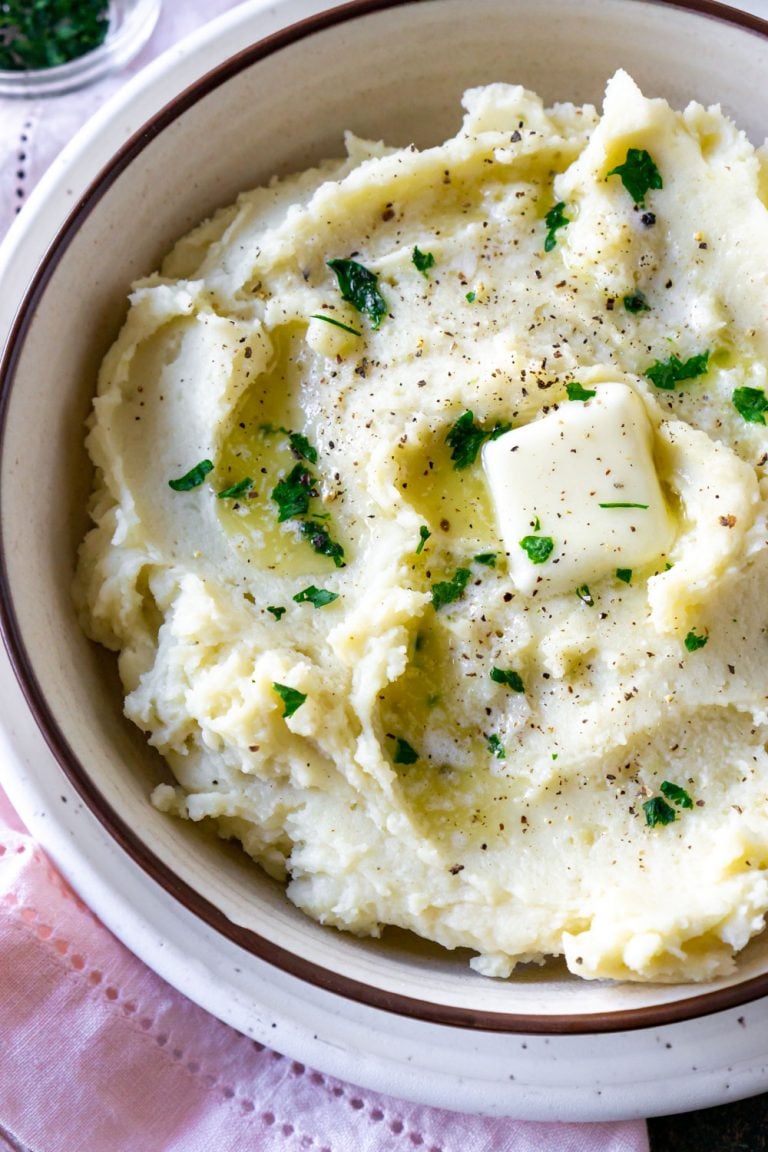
[77,73,768,980]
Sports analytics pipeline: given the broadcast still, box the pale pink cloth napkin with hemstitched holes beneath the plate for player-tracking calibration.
[0,0,648,1152]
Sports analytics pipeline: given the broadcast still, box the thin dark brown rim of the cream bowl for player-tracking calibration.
[0,0,768,1036]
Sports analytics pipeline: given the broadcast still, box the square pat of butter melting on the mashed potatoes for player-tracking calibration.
[482,384,675,596]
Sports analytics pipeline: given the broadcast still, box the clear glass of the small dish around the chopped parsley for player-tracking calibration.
[0,0,161,97]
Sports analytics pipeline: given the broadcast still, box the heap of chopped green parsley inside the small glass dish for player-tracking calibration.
[0,0,111,71]
